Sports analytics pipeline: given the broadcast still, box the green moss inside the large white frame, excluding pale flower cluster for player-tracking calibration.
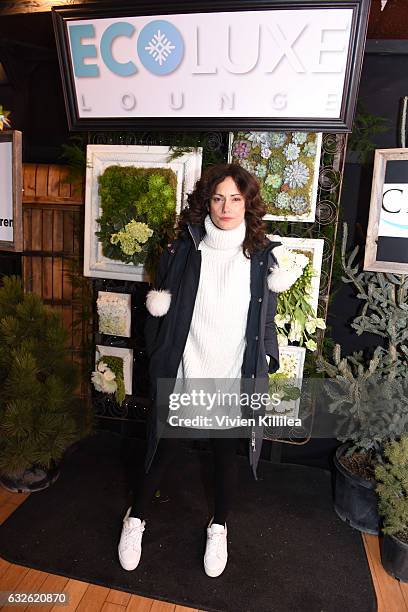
[96,166,177,271]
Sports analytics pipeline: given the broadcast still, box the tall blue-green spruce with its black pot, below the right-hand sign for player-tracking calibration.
[317,225,408,534]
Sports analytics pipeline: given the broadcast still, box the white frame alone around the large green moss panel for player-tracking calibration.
[84,145,202,282]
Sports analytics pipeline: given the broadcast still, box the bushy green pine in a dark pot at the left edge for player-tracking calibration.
[0,276,92,491]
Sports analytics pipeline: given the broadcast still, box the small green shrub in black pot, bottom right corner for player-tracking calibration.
[375,435,408,582]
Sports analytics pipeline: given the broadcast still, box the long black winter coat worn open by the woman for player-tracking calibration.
[144,224,280,480]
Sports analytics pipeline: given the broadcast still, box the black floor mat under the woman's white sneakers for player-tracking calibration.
[0,432,377,612]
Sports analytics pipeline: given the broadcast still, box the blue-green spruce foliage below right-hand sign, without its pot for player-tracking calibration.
[317,224,408,461]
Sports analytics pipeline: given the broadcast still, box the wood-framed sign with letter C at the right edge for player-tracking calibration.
[364,149,408,274]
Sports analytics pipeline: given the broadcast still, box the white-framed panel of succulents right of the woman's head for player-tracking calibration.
[228,132,322,223]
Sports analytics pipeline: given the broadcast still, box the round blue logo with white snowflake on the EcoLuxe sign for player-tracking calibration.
[137,19,184,76]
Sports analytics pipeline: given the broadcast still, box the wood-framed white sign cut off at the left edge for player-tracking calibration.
[0,130,23,251]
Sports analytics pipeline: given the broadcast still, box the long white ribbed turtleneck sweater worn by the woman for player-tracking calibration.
[169,215,250,429]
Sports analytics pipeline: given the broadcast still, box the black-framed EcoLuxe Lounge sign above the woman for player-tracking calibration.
[53,0,370,132]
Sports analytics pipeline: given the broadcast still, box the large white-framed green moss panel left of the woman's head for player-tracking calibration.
[84,145,202,282]
